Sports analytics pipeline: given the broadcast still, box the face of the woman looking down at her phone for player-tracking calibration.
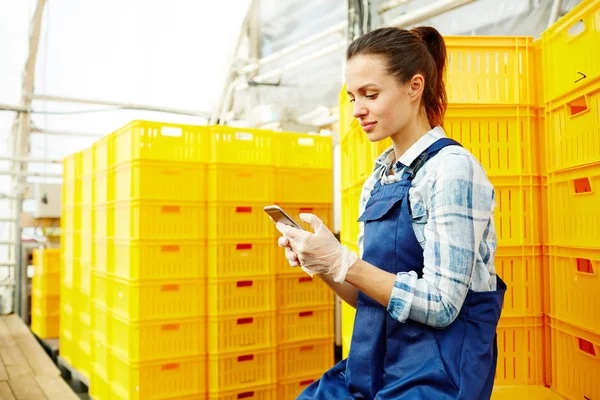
[346,55,418,142]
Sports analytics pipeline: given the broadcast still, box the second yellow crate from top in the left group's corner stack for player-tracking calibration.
[114,161,207,202]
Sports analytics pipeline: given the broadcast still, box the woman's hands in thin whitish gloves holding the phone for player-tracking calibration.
[276,214,358,283]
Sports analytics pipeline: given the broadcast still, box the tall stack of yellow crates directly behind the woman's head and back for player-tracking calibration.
[340,37,544,385]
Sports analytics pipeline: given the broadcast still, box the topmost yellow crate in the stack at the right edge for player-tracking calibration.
[542,0,600,101]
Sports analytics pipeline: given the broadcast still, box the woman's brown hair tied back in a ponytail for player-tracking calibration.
[346,26,447,127]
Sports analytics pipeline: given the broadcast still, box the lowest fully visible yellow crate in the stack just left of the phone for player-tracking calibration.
[208,348,277,392]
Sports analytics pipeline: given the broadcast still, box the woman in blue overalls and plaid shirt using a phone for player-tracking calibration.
[277,27,506,400]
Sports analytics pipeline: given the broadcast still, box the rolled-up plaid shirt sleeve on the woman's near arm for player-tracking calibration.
[388,153,495,328]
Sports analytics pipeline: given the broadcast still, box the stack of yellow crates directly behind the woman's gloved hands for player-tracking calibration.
[272,133,334,400]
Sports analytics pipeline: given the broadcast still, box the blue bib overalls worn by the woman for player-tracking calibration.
[298,138,506,400]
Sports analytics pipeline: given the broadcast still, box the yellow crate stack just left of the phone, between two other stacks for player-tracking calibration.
[207,126,276,399]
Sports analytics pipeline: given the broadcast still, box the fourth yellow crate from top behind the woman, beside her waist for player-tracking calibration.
[495,246,548,317]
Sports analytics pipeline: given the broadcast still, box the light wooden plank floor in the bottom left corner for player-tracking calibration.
[0,315,79,400]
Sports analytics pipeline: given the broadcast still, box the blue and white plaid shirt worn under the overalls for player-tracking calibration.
[358,127,496,328]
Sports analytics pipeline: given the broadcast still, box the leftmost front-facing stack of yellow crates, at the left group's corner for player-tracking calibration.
[108,121,209,400]
